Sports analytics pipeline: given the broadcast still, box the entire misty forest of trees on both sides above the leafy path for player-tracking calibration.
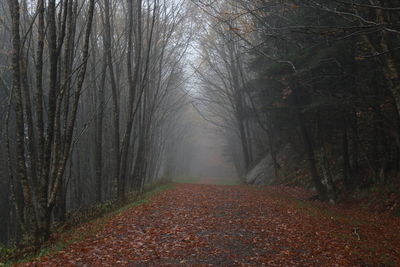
[0,0,400,266]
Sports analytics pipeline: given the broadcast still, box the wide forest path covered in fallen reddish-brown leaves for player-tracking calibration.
[24,184,400,266]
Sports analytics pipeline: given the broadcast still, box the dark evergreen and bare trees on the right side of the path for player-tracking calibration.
[192,0,400,201]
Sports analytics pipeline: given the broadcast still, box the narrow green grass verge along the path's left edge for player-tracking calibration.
[0,182,176,267]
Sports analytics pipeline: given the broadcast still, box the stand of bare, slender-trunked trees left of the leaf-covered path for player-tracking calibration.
[0,0,192,247]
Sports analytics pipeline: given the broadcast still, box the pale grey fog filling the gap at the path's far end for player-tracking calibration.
[164,106,239,183]
